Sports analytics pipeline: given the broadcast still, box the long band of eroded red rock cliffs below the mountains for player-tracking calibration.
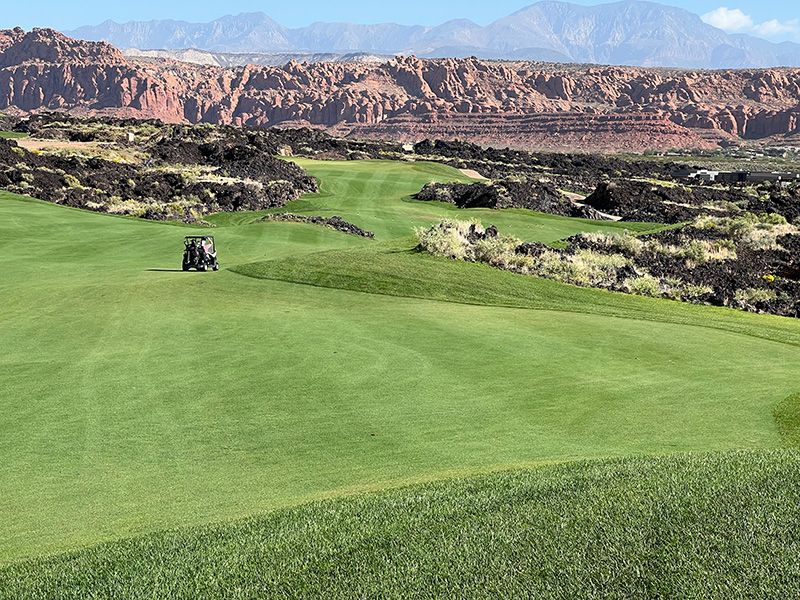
[0,29,800,150]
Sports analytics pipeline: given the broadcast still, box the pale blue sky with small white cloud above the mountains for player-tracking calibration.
[6,0,800,42]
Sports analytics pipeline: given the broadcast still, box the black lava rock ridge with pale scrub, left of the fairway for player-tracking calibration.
[0,124,318,223]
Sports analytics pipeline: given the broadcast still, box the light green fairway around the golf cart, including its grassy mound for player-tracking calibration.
[0,161,800,564]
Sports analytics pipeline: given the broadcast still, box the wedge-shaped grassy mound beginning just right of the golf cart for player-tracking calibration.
[233,238,800,345]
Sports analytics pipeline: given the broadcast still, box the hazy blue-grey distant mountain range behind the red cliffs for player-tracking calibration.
[65,0,800,69]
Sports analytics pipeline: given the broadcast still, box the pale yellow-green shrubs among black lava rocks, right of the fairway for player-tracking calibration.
[416,215,800,316]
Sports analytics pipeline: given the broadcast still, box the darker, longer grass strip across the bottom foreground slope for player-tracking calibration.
[0,451,800,600]
